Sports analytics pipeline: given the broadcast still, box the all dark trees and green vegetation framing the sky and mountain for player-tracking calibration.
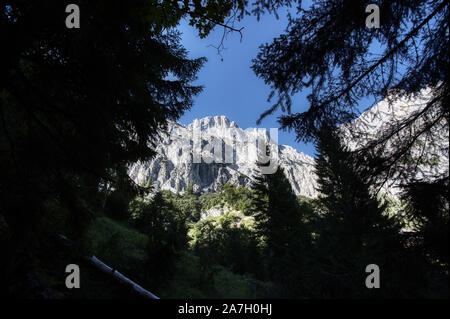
[0,0,450,299]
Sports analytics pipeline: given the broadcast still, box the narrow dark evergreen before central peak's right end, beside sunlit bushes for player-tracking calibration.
[252,164,310,297]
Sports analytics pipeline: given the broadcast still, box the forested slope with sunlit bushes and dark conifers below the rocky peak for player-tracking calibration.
[38,129,448,298]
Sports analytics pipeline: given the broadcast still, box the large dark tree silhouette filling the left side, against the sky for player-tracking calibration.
[0,0,246,296]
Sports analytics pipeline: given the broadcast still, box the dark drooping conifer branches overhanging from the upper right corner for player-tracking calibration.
[253,0,450,189]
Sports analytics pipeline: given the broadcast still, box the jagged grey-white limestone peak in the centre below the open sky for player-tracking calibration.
[129,116,317,197]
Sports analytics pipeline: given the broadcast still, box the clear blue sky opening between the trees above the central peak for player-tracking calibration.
[174,6,314,155]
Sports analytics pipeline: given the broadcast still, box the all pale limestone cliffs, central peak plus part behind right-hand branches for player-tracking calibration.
[129,89,449,198]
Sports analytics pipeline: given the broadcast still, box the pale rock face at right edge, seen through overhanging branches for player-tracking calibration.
[340,88,449,196]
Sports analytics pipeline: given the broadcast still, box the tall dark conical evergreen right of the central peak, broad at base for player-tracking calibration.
[316,129,426,298]
